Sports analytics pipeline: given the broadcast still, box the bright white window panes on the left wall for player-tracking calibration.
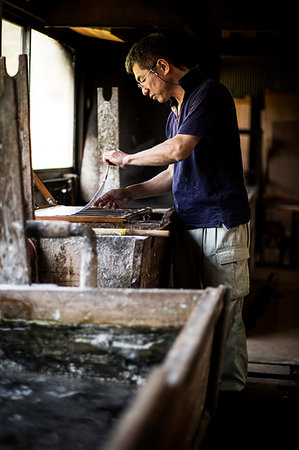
[2,20,75,170]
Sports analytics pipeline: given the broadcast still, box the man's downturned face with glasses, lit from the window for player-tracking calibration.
[133,63,171,103]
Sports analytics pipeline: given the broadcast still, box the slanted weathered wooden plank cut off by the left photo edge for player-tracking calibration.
[0,62,31,284]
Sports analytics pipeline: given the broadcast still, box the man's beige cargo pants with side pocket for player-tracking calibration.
[173,224,250,391]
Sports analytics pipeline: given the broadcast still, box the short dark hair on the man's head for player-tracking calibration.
[125,32,200,74]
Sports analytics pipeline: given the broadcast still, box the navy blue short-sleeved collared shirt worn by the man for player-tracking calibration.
[166,68,250,228]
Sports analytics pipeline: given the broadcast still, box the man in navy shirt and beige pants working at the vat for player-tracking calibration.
[95,34,250,398]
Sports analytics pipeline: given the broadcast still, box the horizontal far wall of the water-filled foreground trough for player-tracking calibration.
[0,284,211,327]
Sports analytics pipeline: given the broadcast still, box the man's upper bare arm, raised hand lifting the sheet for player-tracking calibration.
[103,134,200,168]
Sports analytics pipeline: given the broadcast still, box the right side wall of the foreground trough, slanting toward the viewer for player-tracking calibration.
[104,287,225,450]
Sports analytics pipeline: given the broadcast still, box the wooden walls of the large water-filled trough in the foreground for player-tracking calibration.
[0,285,230,450]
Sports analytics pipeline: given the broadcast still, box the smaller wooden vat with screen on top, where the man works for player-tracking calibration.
[36,207,172,288]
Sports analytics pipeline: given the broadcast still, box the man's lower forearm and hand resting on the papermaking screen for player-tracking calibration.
[94,165,173,208]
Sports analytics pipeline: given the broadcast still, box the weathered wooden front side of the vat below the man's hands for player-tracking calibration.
[37,232,170,288]
